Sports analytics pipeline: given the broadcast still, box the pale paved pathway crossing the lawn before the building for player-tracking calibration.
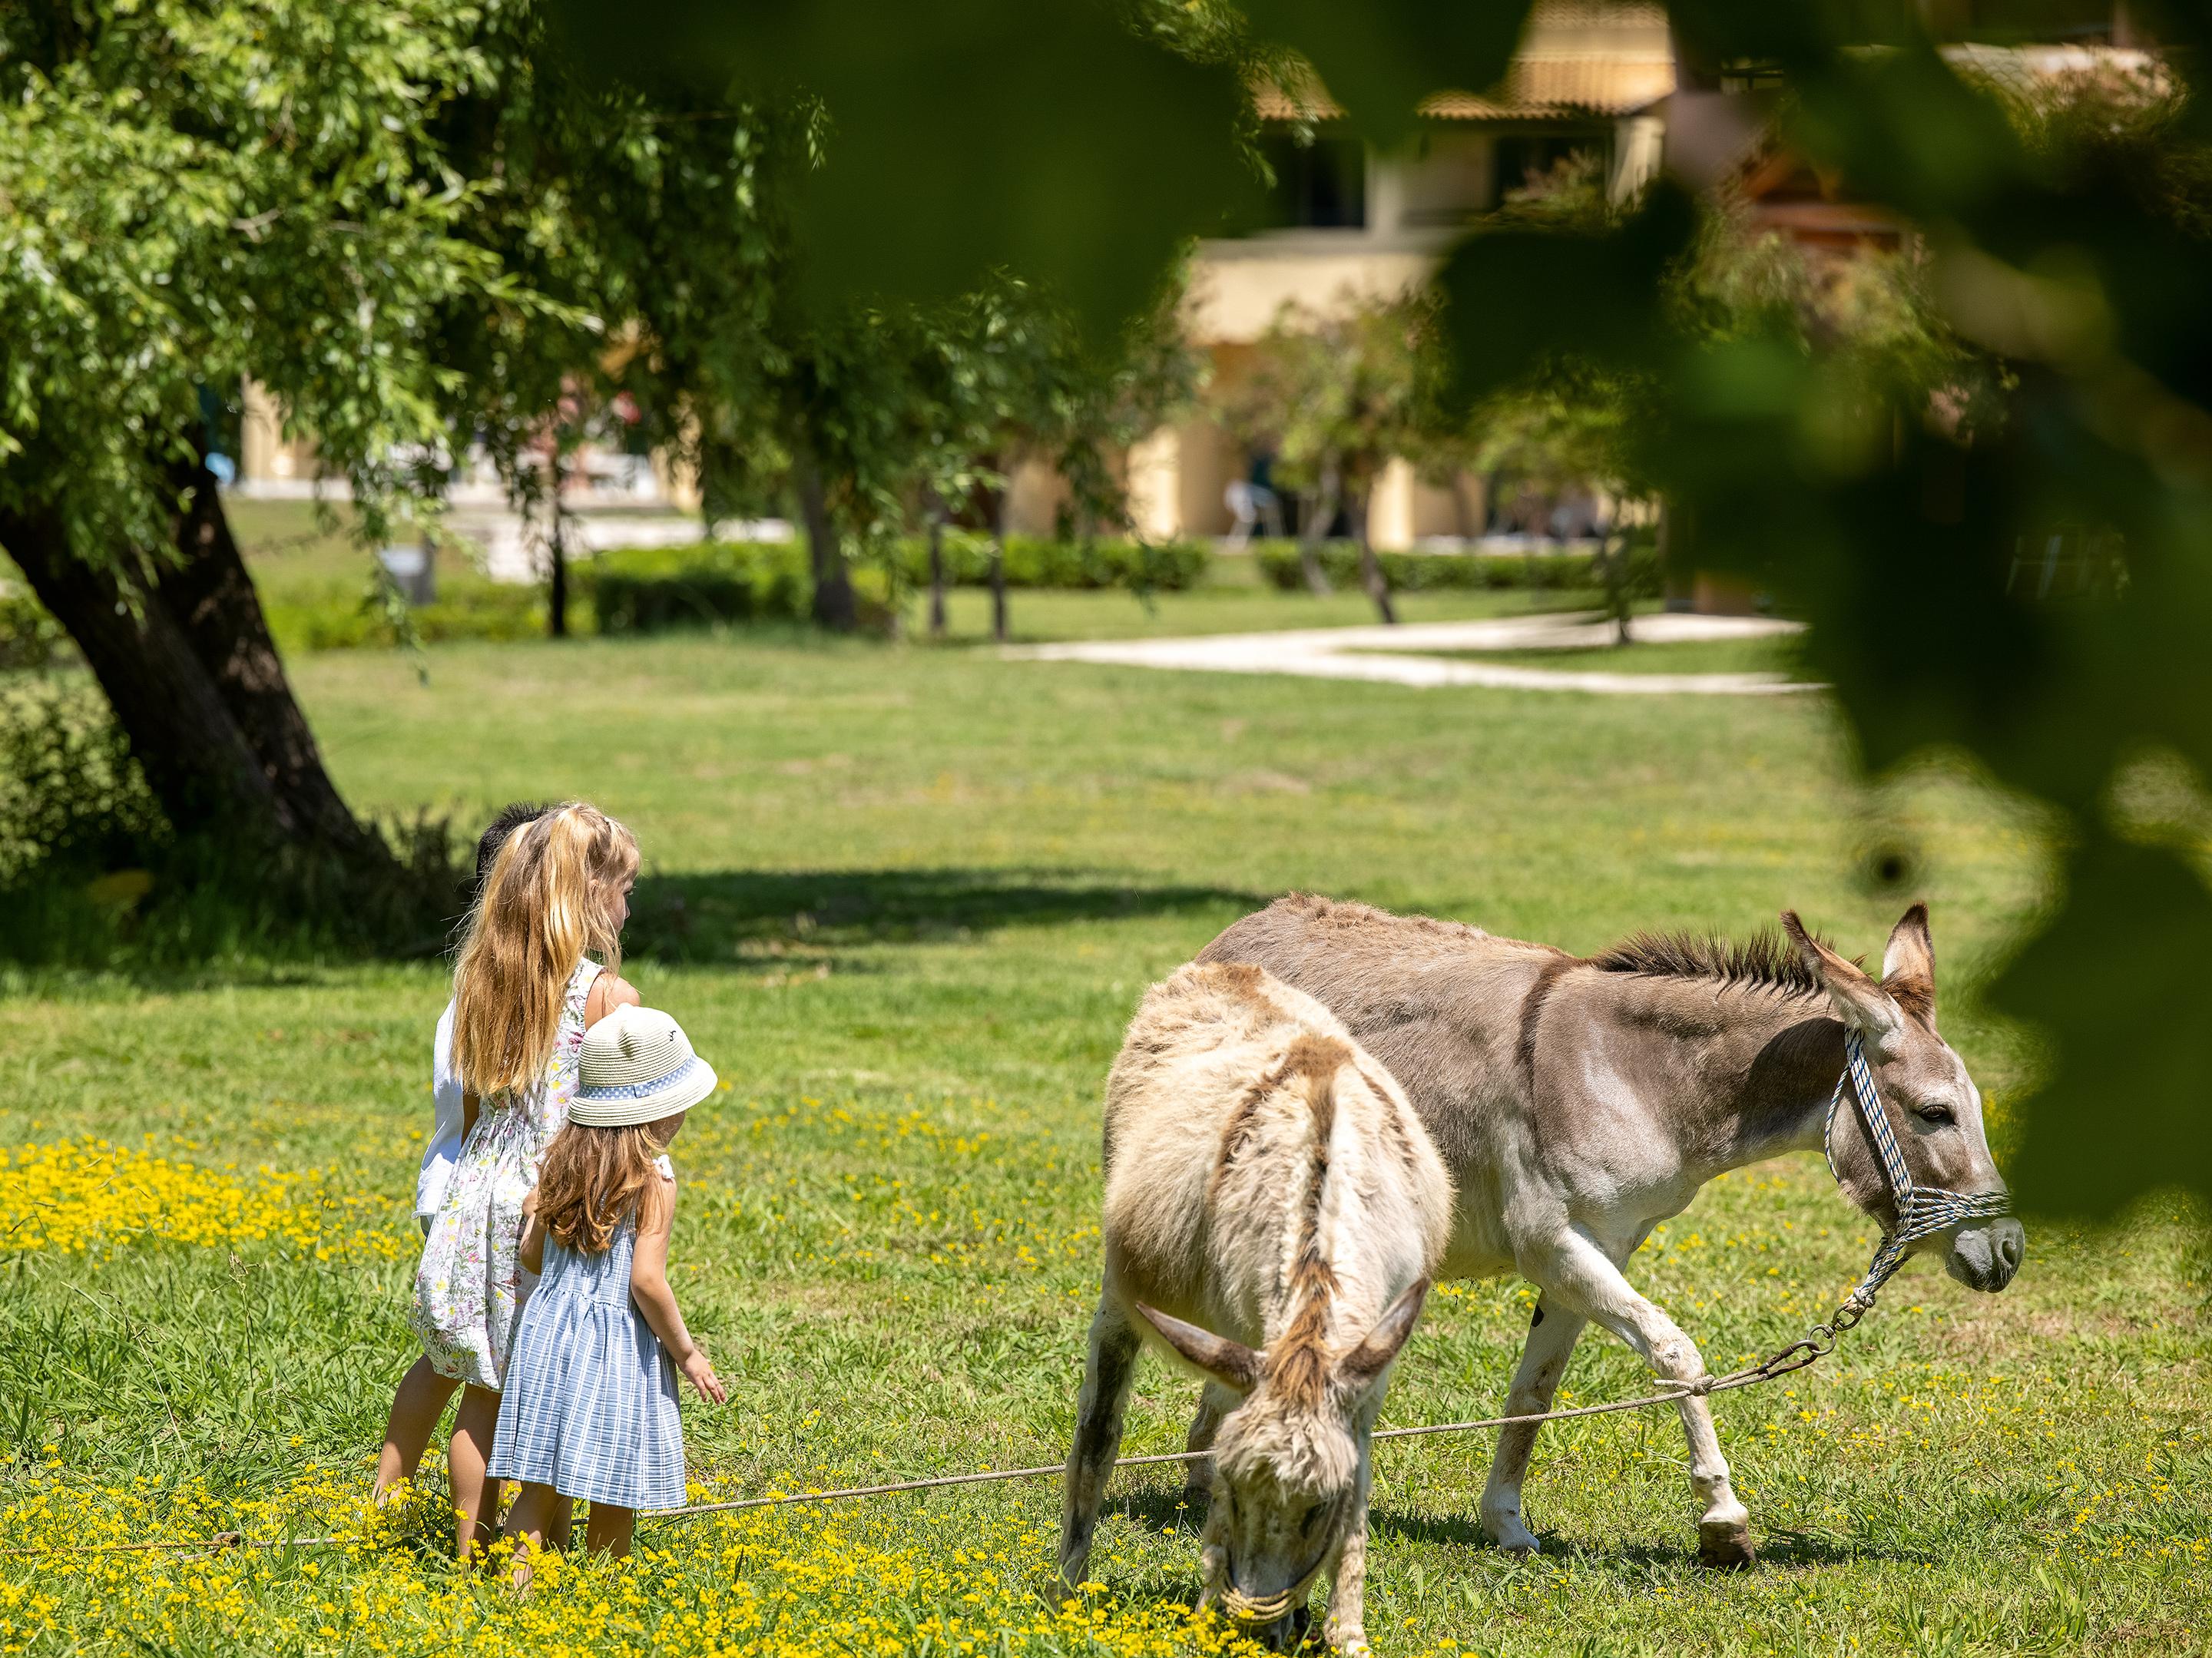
[1008,612,1818,697]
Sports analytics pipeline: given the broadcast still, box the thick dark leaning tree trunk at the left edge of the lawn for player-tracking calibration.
[0,468,392,871]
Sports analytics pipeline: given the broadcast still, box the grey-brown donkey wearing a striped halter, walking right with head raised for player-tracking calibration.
[1192,895,2024,1565]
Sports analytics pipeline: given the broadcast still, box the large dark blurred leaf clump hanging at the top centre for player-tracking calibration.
[555,0,1257,340]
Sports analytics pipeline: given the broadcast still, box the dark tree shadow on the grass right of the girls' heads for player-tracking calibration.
[624,866,1267,961]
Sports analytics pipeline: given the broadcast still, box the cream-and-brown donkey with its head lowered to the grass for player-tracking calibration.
[1060,966,1451,1651]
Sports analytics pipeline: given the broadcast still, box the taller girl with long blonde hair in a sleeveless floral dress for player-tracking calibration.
[414,803,637,1557]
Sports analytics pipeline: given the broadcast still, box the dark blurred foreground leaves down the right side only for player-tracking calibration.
[1445,29,2212,1213]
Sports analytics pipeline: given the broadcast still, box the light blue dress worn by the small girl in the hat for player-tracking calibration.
[487,1158,684,1507]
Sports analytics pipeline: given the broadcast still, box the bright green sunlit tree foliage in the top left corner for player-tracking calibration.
[0,0,533,559]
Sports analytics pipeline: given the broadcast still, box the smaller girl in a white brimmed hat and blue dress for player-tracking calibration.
[488,1008,728,1585]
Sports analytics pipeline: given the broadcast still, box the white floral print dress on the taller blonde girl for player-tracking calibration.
[414,961,599,1391]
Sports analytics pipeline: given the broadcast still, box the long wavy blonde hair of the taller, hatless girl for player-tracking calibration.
[453,800,637,1101]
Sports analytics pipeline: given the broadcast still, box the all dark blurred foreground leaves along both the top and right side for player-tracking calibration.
[539,0,2212,1213]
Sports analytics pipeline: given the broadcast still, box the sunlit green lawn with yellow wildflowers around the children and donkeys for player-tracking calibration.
[0,627,2212,1658]
